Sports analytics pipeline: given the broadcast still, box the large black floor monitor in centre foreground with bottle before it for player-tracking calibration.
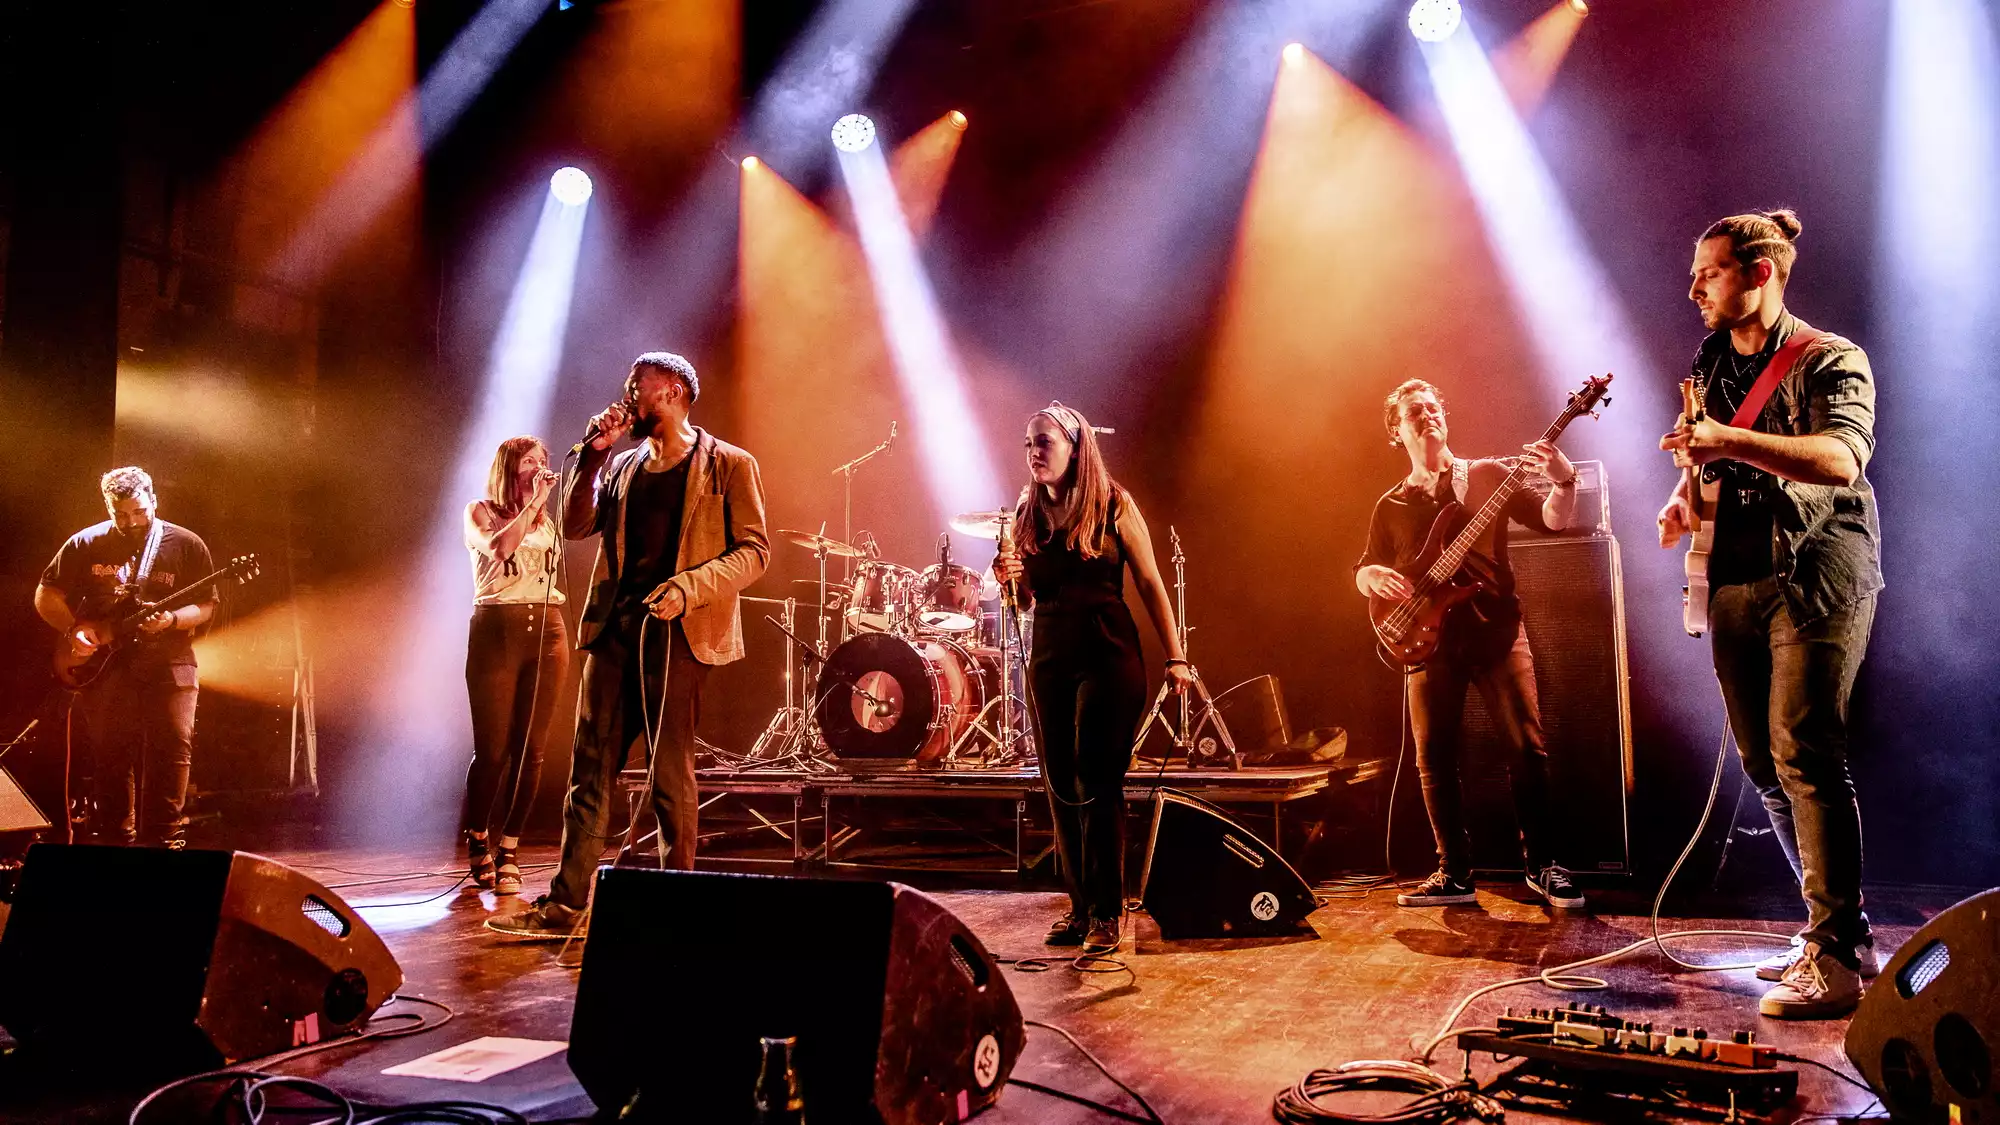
[570,867,1026,1125]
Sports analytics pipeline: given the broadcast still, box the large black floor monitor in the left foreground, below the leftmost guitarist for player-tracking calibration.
[0,845,402,1071]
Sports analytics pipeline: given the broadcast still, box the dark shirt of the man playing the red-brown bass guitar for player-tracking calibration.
[1354,458,1548,659]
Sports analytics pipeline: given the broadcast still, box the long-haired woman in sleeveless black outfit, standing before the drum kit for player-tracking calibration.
[994,402,1194,949]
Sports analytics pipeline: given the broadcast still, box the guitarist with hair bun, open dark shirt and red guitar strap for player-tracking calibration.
[1660,210,1882,1019]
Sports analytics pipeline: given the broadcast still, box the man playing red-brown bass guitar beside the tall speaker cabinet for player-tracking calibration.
[1354,378,1584,907]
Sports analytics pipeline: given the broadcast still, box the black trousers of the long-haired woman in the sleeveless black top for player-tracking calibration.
[1028,605,1146,921]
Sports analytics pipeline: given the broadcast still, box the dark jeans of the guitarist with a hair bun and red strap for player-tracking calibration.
[1708,579,1874,951]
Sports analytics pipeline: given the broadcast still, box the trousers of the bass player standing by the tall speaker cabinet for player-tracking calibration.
[1408,627,1550,879]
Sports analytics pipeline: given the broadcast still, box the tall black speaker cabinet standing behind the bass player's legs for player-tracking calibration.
[1462,536,1632,873]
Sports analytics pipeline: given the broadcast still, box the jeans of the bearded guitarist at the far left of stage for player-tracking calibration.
[74,663,200,845]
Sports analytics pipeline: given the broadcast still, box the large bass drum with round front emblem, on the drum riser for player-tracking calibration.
[812,633,988,763]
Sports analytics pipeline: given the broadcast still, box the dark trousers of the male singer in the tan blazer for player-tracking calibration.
[548,619,708,909]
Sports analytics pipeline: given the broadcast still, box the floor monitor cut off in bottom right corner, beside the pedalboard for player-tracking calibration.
[1846,889,2000,1123]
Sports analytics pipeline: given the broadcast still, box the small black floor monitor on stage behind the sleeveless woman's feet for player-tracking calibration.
[1142,789,1318,941]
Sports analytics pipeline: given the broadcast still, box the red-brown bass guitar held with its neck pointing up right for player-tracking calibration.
[1368,374,1612,673]
